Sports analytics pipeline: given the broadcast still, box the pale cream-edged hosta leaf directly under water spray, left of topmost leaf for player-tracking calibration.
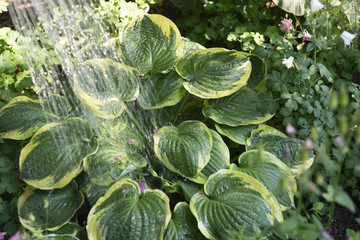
[74,58,139,119]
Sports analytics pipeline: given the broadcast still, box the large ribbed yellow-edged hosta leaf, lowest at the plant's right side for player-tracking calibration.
[190,169,283,239]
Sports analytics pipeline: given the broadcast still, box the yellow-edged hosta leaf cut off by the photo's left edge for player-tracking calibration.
[0,96,59,140]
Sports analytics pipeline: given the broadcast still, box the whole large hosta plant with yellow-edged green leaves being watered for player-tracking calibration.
[0,15,313,240]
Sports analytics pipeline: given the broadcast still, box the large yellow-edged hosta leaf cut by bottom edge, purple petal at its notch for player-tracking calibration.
[86,179,171,240]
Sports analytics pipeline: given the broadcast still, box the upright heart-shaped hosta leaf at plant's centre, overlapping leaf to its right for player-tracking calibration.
[154,121,213,177]
